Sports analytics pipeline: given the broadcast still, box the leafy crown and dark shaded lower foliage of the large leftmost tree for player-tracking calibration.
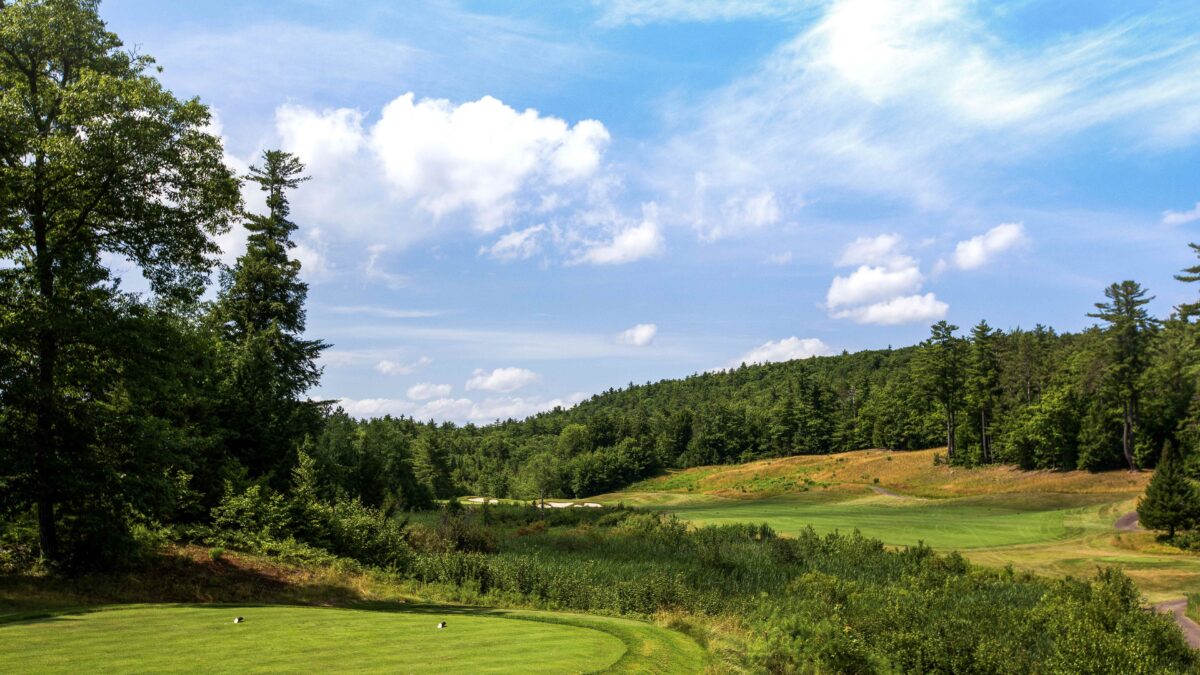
[0,0,239,566]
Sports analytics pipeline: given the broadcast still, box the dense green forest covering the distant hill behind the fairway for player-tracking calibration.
[313,268,1200,503]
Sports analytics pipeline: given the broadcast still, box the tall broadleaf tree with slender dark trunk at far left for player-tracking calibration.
[0,0,239,561]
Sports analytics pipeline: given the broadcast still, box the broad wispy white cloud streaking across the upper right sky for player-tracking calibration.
[652,0,1200,229]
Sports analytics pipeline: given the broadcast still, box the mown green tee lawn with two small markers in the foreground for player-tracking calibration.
[0,605,703,673]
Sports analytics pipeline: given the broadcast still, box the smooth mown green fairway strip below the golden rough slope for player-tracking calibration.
[646,494,1113,549]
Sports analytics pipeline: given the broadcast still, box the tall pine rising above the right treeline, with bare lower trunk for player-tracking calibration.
[1087,281,1158,471]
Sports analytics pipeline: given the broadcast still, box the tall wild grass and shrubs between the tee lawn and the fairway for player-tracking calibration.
[398,507,1198,673]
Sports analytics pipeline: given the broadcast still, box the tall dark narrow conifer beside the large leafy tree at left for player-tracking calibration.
[214,150,328,482]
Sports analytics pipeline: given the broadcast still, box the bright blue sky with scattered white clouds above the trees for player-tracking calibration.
[101,0,1200,422]
